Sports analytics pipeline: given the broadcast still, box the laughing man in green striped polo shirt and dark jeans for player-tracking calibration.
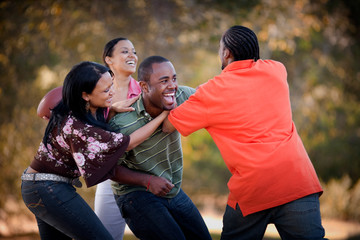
[110,56,211,239]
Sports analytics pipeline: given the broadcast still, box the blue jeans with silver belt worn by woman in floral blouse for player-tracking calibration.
[21,181,113,240]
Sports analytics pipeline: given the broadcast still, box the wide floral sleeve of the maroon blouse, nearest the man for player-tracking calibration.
[62,118,130,187]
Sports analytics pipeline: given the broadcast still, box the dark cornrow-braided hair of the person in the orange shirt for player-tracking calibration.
[222,26,260,61]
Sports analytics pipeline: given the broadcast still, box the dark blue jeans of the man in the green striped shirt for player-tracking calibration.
[115,190,211,240]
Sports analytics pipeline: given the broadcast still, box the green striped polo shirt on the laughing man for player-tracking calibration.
[109,86,195,198]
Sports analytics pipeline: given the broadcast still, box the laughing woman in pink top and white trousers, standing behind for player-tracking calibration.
[94,38,141,240]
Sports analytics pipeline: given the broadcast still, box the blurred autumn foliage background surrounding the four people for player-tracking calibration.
[0,0,360,239]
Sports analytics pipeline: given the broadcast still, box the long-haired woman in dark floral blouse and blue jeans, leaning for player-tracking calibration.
[22,62,172,239]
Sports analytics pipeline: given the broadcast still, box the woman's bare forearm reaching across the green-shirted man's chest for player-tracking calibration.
[126,111,169,151]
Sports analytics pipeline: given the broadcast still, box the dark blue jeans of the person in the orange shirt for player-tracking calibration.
[221,194,325,240]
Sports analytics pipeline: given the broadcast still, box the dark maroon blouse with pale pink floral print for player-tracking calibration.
[30,115,130,187]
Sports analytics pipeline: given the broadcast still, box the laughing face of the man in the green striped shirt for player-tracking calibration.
[142,62,178,117]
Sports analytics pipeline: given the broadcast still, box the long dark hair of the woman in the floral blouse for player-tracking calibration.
[43,62,112,146]
